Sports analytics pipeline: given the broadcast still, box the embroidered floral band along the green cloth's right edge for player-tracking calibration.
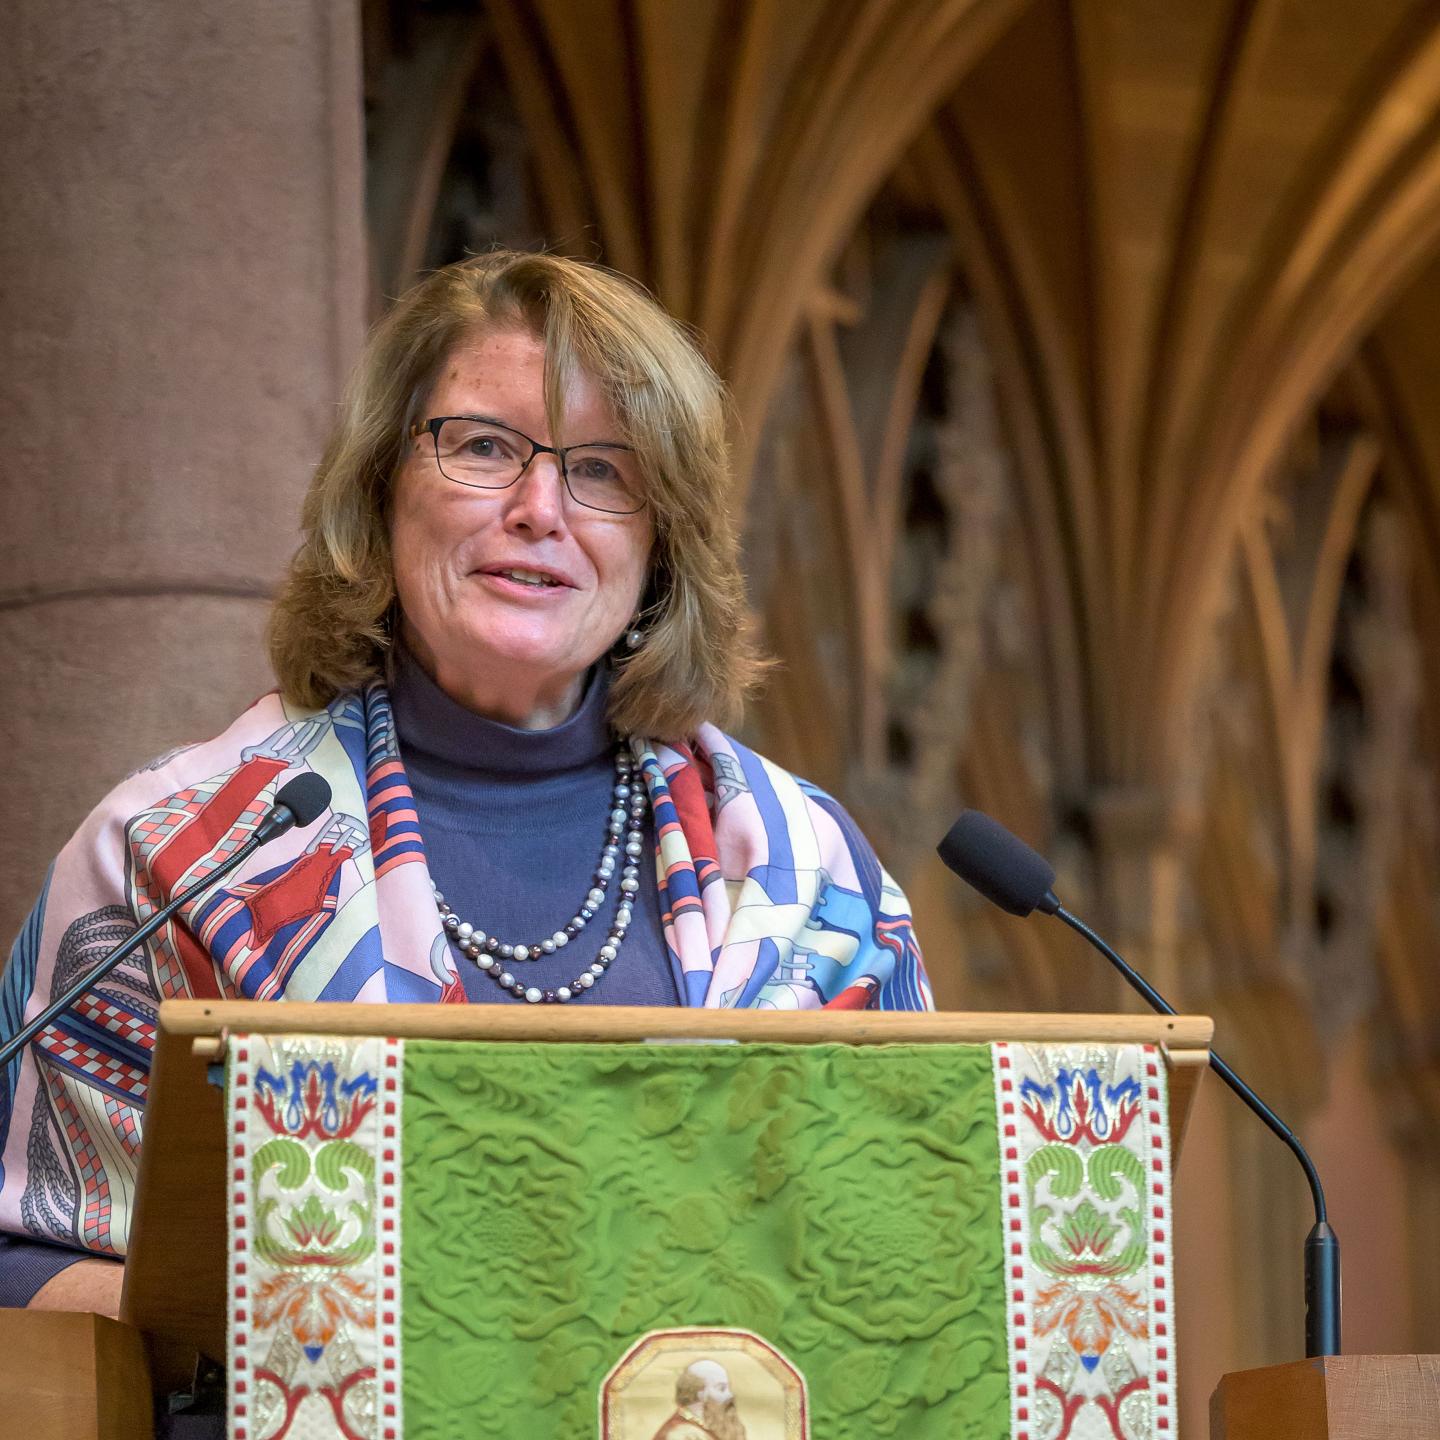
[992,1043,1175,1440]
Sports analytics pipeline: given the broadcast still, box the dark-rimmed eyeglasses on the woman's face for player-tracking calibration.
[410,415,645,516]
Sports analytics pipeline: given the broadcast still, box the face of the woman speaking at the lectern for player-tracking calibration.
[390,328,654,727]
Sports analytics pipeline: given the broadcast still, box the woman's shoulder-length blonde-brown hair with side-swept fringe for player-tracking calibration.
[268,251,763,740]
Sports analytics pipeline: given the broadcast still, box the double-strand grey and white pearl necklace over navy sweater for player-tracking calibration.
[432,742,648,1005]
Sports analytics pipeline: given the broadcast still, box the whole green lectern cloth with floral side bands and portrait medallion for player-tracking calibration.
[228,1035,1175,1440]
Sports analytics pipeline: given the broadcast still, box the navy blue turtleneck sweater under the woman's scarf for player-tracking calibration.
[390,649,680,1005]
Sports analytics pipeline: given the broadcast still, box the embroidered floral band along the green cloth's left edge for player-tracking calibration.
[228,1035,403,1440]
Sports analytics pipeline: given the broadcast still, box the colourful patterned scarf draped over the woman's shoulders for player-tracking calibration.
[0,684,933,1254]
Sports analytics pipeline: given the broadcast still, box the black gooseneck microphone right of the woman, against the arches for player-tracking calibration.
[936,811,1341,1358]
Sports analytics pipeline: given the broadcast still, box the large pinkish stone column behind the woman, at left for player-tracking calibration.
[0,0,366,958]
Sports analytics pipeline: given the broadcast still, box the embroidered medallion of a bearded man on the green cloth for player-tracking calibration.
[600,1329,809,1440]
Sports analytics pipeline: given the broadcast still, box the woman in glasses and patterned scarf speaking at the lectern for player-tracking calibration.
[0,252,930,1312]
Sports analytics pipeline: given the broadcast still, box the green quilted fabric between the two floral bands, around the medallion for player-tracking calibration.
[402,1041,1009,1440]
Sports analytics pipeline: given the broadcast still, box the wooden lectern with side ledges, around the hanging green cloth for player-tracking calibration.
[25,1001,1416,1440]
